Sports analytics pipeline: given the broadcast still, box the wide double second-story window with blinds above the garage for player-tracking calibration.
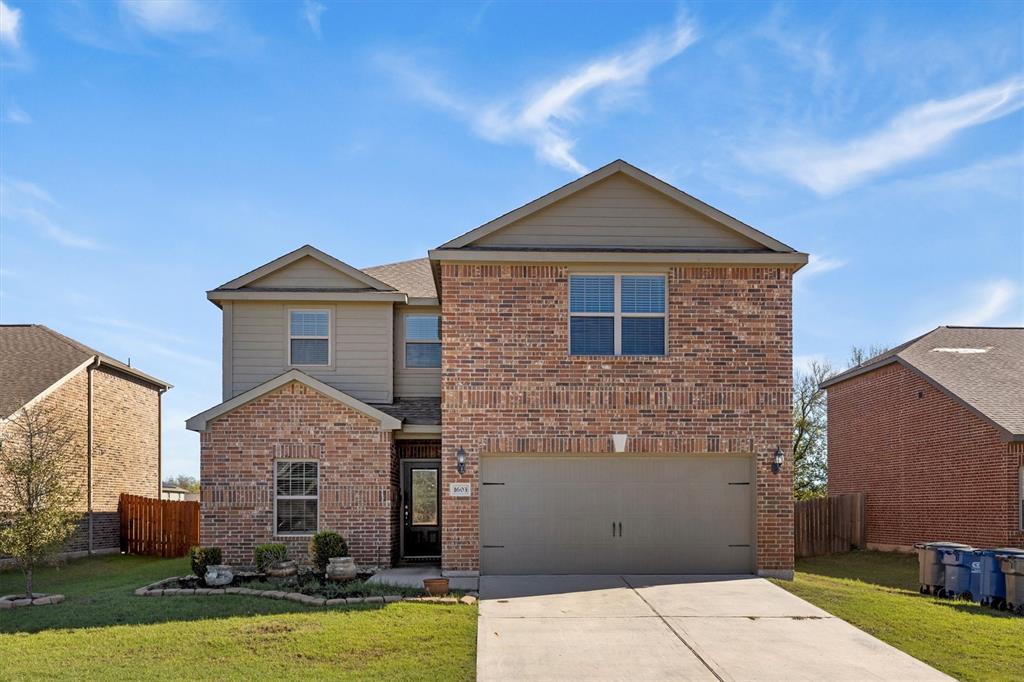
[569,274,666,355]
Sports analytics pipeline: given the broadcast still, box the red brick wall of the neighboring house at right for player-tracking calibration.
[828,364,1024,548]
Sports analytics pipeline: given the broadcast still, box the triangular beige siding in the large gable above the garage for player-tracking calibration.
[476,174,763,250]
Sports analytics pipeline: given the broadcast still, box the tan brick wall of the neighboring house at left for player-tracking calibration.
[1,367,160,553]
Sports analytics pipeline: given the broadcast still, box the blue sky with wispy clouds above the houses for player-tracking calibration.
[0,0,1024,474]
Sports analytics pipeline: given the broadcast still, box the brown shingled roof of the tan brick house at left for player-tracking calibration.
[0,325,171,417]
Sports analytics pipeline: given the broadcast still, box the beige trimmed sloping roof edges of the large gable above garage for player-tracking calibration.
[436,159,797,253]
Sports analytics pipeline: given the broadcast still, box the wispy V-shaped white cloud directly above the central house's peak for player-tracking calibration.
[381,19,696,173]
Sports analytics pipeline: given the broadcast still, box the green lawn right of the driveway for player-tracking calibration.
[776,552,1024,680]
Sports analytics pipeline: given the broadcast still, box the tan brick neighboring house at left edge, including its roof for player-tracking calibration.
[0,325,171,554]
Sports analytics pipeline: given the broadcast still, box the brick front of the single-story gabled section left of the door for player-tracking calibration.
[200,382,397,566]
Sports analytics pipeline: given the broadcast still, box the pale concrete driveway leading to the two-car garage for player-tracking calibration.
[476,576,951,681]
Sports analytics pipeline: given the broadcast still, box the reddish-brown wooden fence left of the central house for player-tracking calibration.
[118,494,199,557]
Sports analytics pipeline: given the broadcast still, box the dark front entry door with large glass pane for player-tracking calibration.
[401,461,441,559]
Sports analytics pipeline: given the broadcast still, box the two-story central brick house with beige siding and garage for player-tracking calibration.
[187,161,807,577]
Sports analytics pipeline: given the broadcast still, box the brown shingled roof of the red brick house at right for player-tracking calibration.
[821,327,1024,440]
